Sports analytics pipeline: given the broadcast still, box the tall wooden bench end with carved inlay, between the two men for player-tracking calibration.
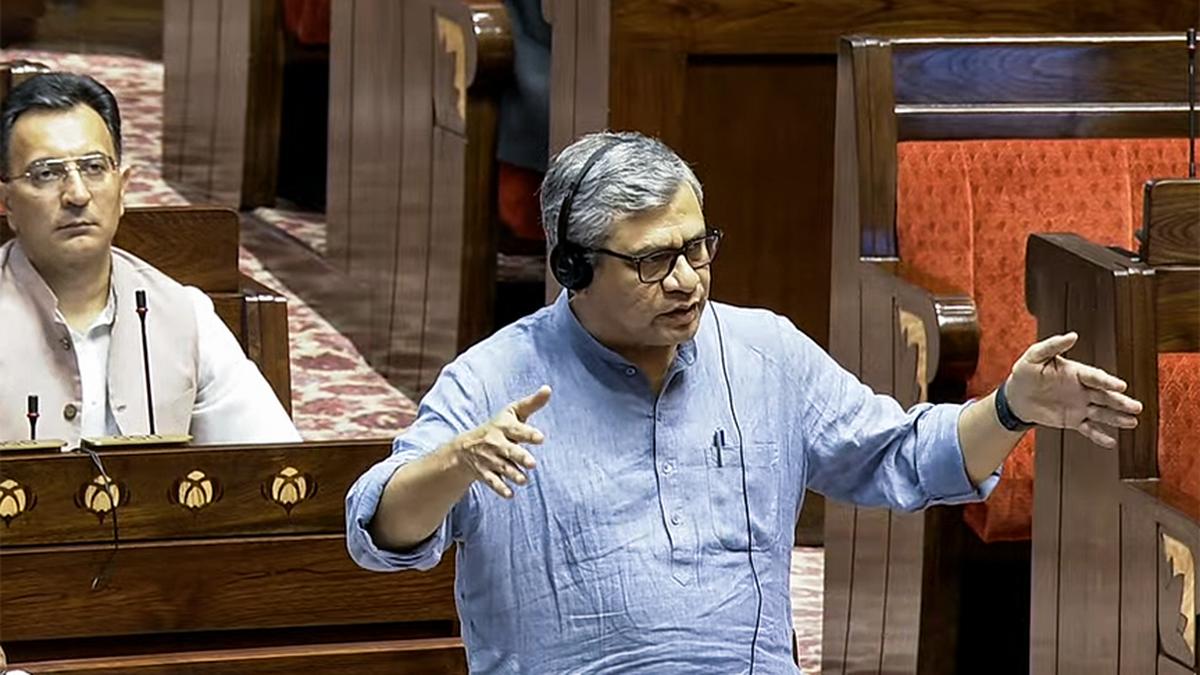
[304,0,511,395]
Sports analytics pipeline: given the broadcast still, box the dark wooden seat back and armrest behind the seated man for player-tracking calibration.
[0,207,292,412]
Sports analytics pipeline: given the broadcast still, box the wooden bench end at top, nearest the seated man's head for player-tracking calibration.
[162,0,283,207]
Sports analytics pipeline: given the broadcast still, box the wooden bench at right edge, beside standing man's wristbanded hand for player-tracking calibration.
[1026,178,1200,675]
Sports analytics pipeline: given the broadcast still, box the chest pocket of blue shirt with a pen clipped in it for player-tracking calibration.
[704,442,782,551]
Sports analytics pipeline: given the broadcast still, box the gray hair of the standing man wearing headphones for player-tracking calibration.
[541,132,704,250]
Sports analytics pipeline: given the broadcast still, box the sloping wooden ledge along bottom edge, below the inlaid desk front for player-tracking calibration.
[16,638,467,675]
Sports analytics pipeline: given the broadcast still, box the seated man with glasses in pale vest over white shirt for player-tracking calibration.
[0,73,300,449]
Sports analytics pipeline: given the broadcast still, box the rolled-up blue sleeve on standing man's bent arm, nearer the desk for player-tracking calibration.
[346,364,487,572]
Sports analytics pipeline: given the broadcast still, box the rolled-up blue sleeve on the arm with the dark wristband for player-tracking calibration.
[793,317,1000,510]
